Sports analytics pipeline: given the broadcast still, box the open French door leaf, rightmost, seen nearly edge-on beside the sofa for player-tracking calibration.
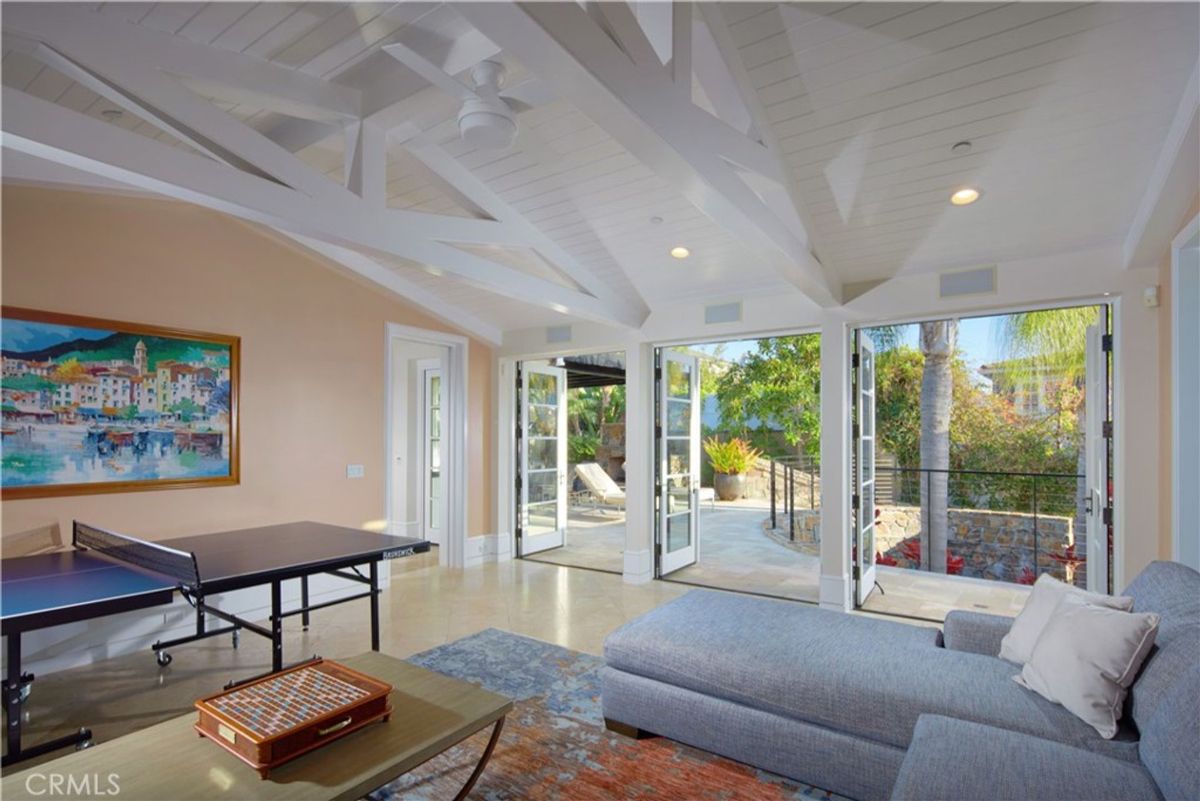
[1084,325,1109,592]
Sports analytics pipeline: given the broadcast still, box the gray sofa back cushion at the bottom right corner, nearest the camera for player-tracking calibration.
[1139,654,1200,801]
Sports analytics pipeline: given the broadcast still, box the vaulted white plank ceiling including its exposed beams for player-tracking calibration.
[0,2,1200,341]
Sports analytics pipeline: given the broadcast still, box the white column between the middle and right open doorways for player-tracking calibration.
[820,309,853,612]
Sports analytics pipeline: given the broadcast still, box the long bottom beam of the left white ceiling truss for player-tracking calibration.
[0,86,640,326]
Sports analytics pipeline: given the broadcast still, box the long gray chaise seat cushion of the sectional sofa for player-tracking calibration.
[605,591,1136,759]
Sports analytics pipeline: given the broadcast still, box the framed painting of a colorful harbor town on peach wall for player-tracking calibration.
[0,306,240,500]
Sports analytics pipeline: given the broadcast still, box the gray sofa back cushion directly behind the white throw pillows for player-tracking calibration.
[1124,562,1200,729]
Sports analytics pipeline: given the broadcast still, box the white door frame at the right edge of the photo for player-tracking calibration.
[1171,216,1200,570]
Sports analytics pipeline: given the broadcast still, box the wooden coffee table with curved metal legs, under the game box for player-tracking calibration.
[0,652,512,801]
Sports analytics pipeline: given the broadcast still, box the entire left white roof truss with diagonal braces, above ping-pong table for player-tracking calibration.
[2,5,647,327]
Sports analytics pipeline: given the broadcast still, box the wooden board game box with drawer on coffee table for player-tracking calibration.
[196,660,391,778]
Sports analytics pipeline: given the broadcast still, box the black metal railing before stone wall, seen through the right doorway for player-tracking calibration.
[864,465,1092,586]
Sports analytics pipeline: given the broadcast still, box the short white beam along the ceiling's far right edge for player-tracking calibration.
[1123,62,1200,269]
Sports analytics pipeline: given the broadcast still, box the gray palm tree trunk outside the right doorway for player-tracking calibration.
[920,320,959,573]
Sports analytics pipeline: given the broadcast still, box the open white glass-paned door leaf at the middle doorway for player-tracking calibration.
[659,349,700,576]
